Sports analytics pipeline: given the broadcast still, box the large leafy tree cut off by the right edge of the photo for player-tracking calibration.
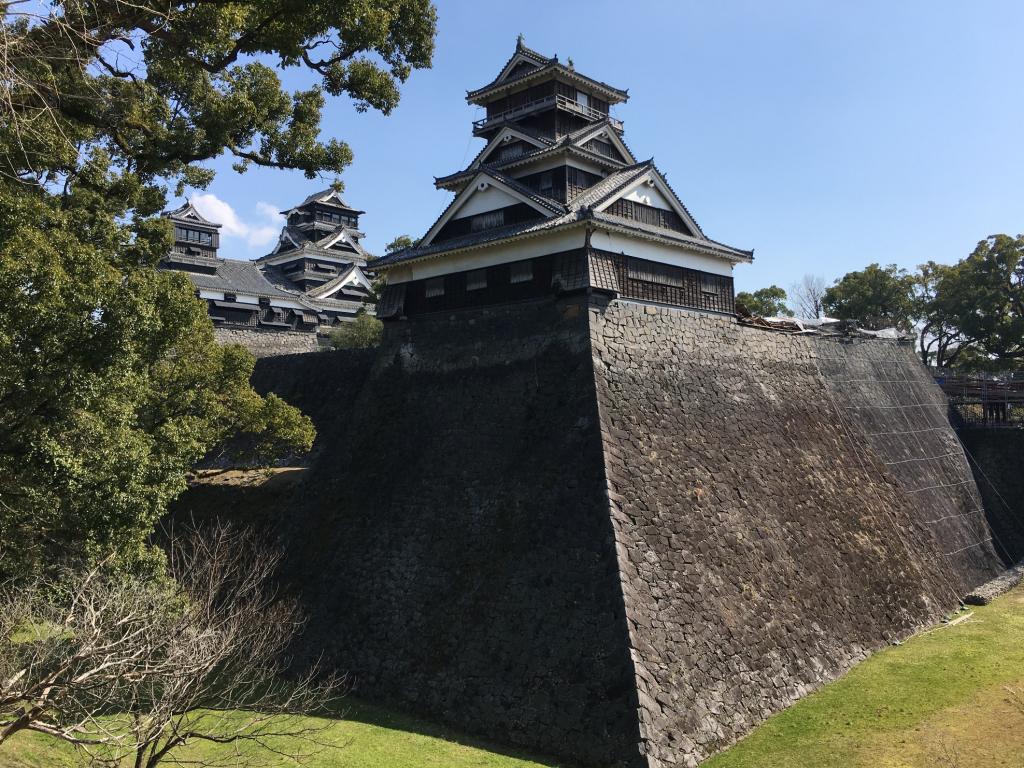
[932,234,1024,368]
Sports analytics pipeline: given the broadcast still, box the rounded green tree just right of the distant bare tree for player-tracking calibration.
[821,264,914,331]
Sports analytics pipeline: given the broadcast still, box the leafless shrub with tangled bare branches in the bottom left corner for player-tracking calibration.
[0,525,342,768]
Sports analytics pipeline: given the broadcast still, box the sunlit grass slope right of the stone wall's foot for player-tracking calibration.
[702,586,1024,768]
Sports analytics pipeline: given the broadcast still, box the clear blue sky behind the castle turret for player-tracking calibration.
[184,0,1024,290]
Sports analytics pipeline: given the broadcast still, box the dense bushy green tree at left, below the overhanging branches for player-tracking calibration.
[0,178,313,572]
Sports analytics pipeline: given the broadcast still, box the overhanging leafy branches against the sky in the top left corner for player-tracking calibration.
[0,0,436,183]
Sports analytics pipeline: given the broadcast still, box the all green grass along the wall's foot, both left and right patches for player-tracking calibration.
[0,586,1024,768]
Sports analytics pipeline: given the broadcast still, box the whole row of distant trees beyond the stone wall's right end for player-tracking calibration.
[736,234,1024,371]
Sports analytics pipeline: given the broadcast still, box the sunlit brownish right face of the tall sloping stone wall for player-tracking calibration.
[591,302,997,766]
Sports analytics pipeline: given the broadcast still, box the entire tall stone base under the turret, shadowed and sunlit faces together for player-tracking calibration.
[179,296,999,768]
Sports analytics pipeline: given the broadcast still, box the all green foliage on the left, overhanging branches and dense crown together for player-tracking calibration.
[0,0,435,573]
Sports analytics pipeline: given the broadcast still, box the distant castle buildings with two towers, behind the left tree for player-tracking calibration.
[162,189,374,356]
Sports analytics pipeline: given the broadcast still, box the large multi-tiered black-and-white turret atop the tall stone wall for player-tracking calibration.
[374,37,754,319]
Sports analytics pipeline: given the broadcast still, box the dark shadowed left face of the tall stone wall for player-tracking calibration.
[268,299,639,765]
